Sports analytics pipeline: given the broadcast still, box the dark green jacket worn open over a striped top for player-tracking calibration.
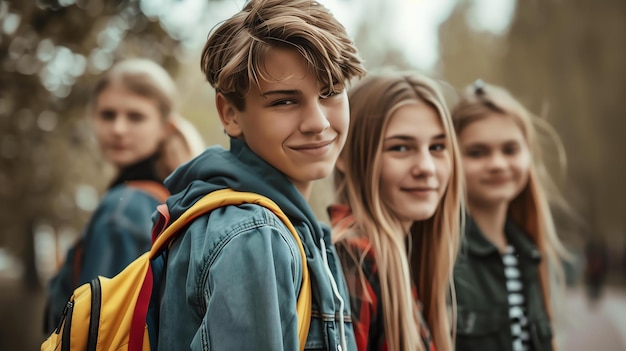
[454,216,552,351]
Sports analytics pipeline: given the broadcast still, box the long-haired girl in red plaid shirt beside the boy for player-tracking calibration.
[329,73,462,351]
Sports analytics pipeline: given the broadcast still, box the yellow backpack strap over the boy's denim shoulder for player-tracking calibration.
[150,189,311,350]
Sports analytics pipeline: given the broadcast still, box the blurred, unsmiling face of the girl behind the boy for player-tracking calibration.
[92,83,166,169]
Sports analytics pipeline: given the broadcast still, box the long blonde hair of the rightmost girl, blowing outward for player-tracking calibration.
[452,80,569,317]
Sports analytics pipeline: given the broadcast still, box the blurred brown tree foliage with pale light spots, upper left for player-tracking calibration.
[0,0,208,287]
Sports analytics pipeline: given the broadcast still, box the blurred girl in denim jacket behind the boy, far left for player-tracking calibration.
[45,59,204,333]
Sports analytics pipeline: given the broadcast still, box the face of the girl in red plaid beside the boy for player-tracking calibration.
[380,102,452,232]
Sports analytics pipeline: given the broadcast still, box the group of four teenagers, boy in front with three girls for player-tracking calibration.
[48,0,563,351]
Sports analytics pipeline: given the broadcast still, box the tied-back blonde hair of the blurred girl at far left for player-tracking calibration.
[90,58,205,179]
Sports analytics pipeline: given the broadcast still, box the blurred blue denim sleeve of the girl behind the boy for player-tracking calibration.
[79,186,158,284]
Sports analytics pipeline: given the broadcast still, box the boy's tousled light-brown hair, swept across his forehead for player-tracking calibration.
[200,0,365,111]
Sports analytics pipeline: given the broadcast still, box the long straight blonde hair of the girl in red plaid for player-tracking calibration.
[334,73,463,351]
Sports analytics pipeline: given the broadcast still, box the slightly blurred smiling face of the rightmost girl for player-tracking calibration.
[459,113,531,206]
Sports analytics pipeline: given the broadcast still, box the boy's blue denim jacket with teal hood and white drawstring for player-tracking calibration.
[158,140,356,351]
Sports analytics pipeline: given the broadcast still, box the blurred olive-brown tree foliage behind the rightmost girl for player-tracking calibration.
[440,0,626,260]
